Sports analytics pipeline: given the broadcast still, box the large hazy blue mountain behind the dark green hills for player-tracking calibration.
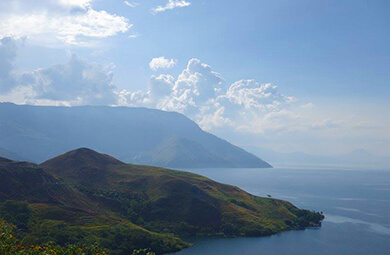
[0,103,271,168]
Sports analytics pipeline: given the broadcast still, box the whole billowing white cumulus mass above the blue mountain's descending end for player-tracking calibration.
[120,59,297,133]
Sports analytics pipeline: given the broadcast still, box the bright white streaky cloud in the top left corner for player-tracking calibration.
[0,0,132,46]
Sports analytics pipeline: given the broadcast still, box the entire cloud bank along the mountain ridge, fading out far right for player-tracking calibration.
[0,37,371,150]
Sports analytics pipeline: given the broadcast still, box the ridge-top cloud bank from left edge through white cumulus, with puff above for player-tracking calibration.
[0,37,296,133]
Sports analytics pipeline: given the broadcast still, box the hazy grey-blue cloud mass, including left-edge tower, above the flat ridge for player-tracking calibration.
[0,37,118,105]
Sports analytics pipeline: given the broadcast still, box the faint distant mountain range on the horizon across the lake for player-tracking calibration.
[246,147,390,168]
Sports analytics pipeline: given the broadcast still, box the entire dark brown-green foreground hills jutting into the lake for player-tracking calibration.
[0,148,323,255]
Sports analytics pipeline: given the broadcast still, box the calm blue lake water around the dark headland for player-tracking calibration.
[169,168,390,255]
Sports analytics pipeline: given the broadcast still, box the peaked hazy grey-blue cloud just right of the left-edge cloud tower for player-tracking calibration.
[20,55,117,105]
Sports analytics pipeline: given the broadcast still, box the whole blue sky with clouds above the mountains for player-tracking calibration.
[0,0,390,156]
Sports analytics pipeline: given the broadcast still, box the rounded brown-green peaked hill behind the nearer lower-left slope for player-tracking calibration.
[41,149,322,235]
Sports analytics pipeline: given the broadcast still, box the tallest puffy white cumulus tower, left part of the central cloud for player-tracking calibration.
[121,59,224,117]
